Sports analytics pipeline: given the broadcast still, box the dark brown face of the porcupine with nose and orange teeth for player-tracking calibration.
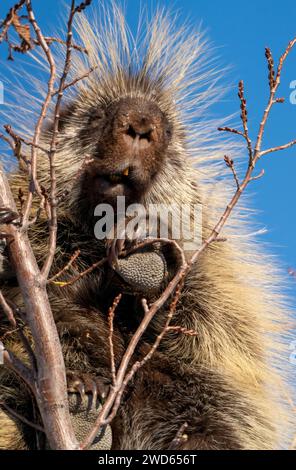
[80,98,171,207]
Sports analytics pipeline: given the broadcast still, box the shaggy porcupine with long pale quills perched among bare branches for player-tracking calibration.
[0,0,292,450]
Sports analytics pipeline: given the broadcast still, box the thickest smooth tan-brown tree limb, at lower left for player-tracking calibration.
[0,165,78,449]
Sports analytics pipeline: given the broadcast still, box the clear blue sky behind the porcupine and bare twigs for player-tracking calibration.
[0,0,296,276]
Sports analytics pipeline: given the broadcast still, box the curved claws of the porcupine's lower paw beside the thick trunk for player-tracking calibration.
[66,371,109,407]
